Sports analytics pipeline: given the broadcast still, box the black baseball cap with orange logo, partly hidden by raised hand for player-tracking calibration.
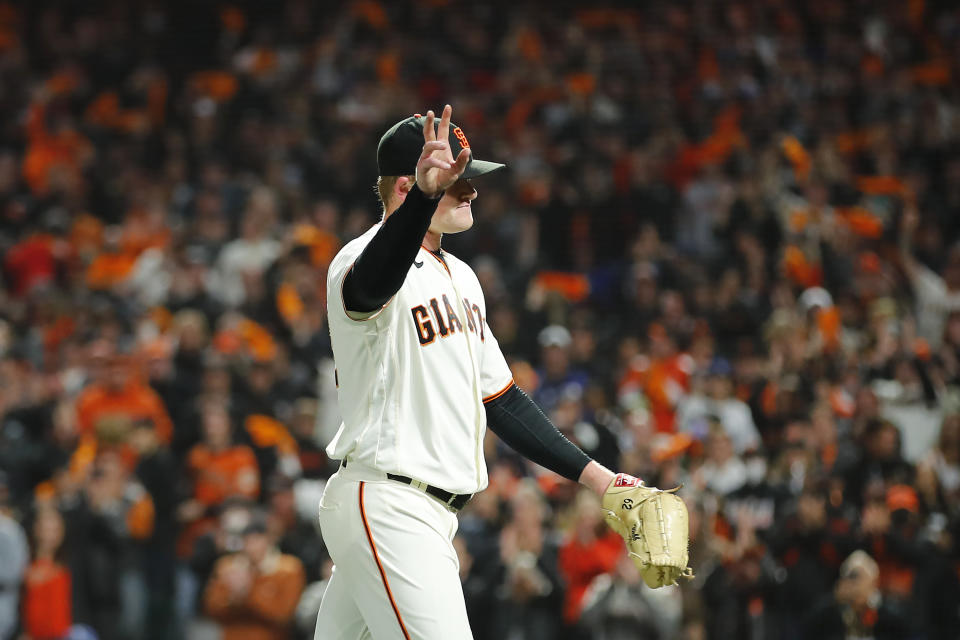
[377,113,506,178]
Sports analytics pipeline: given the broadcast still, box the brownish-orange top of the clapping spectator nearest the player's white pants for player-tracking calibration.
[203,553,306,640]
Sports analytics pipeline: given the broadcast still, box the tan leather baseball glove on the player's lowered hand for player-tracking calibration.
[603,473,693,589]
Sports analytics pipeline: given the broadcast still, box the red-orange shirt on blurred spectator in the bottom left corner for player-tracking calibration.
[22,559,73,640]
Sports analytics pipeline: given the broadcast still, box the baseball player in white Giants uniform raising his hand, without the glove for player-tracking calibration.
[315,105,686,640]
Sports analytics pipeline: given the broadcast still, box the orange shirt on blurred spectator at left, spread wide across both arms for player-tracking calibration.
[77,380,173,444]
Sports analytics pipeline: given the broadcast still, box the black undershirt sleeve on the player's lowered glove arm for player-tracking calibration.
[484,385,590,482]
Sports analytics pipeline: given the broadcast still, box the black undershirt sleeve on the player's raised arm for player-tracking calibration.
[343,185,438,313]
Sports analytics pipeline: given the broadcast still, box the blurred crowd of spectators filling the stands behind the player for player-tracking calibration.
[0,0,960,640]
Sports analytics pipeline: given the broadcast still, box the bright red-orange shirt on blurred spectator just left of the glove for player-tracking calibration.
[557,531,623,624]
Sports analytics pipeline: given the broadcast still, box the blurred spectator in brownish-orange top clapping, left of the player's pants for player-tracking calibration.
[203,516,305,640]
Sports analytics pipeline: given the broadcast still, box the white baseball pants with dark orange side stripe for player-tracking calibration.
[314,461,473,640]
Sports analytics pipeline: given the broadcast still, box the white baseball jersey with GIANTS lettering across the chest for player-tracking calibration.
[327,224,513,493]
